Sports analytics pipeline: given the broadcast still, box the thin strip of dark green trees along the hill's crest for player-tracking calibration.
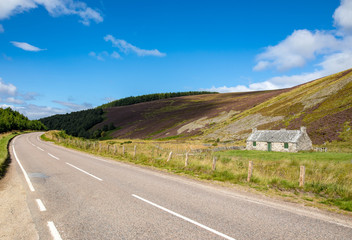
[100,91,217,108]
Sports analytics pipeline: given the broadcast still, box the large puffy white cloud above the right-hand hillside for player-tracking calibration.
[253,29,340,71]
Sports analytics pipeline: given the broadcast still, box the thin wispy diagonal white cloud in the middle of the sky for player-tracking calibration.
[104,35,166,57]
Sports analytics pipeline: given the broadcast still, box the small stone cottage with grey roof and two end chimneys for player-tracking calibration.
[246,127,312,152]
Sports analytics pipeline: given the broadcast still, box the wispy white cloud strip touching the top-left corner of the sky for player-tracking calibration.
[0,0,103,26]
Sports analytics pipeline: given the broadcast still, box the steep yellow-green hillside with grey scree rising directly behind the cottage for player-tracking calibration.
[206,69,352,144]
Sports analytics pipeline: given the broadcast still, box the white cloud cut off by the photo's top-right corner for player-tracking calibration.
[333,0,352,31]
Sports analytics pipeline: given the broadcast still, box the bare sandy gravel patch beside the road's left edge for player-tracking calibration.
[0,163,39,240]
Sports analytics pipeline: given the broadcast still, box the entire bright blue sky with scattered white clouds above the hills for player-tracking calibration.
[0,0,352,119]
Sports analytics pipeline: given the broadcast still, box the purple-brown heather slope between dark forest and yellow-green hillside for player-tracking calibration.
[94,90,287,139]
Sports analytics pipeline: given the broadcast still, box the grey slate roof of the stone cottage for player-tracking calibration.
[247,130,303,143]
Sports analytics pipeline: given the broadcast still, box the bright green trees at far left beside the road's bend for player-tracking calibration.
[0,108,46,133]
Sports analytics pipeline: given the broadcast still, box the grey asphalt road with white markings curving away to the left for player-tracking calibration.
[6,133,352,240]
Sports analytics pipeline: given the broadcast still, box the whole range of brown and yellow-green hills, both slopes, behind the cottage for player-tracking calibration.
[40,69,352,144]
